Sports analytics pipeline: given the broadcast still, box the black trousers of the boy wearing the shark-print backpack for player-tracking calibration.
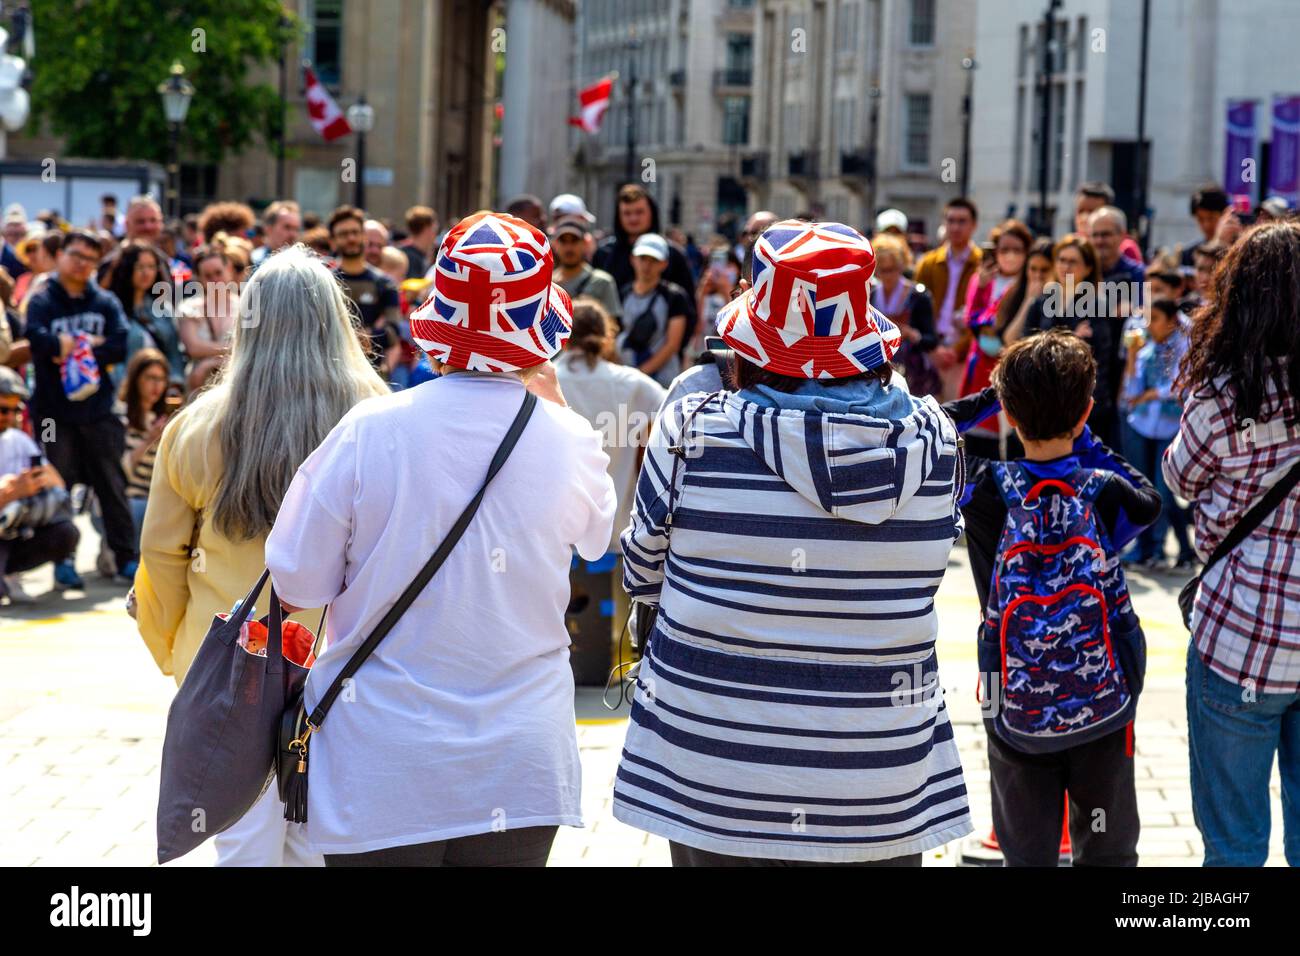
[988,730,1141,866]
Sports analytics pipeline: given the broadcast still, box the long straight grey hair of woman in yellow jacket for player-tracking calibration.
[208,243,389,540]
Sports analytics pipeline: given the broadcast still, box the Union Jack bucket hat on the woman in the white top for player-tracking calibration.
[411,212,573,372]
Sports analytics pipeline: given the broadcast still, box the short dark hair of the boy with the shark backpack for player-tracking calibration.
[993,329,1097,441]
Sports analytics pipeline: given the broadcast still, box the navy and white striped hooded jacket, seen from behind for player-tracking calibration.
[614,385,971,862]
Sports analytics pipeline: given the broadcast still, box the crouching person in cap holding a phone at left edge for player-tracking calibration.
[0,367,81,604]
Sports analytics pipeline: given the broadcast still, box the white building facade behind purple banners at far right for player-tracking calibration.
[972,0,1300,250]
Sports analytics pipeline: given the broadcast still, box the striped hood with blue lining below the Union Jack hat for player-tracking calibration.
[722,376,957,524]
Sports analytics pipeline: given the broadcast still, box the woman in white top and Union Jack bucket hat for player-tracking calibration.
[267,212,616,866]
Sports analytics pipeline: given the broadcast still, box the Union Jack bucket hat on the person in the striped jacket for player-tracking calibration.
[718,220,902,378]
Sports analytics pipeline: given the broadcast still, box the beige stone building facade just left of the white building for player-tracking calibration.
[744,0,975,238]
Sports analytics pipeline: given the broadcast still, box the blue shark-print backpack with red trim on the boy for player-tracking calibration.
[979,462,1147,753]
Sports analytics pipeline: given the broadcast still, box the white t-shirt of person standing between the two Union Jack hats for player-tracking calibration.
[555,352,667,551]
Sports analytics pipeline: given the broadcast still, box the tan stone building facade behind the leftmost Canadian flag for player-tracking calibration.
[218,0,502,221]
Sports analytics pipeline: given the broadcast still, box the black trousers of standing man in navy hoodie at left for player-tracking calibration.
[44,416,139,571]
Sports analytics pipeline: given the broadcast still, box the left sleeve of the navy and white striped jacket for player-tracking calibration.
[619,395,699,605]
